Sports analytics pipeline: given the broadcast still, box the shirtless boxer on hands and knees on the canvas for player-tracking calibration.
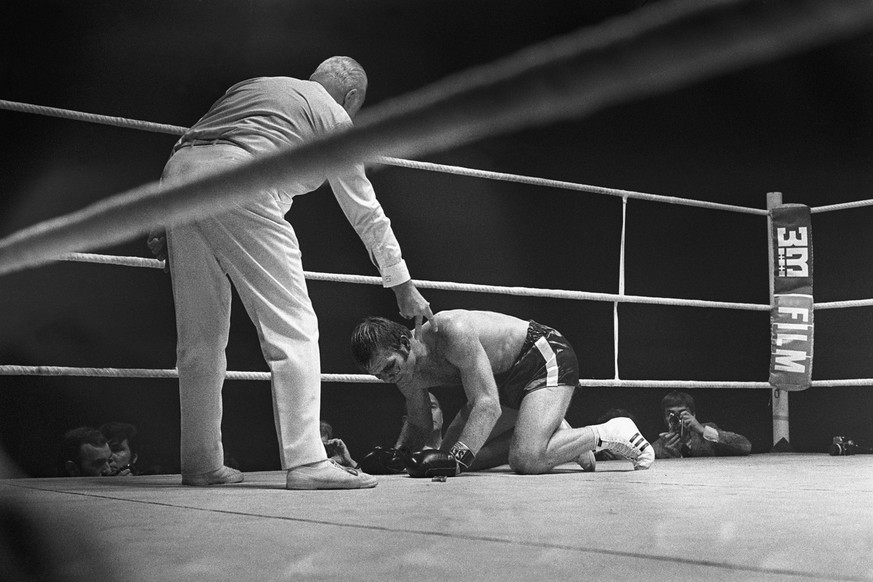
[352,310,655,476]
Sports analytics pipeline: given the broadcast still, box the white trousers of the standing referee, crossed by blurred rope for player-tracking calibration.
[162,145,326,475]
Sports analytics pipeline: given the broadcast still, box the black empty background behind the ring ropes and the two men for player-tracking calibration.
[0,0,873,476]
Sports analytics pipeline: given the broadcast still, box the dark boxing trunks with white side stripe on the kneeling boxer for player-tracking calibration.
[494,320,579,410]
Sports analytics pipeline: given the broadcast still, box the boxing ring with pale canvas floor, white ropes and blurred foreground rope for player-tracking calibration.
[0,2,873,580]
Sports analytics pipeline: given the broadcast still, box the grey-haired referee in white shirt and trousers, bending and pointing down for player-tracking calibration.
[148,57,433,489]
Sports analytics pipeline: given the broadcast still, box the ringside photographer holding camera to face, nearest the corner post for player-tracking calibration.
[652,390,752,459]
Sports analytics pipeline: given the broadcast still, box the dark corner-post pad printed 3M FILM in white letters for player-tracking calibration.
[770,204,814,391]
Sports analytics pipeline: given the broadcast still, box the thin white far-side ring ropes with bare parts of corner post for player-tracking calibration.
[0,100,873,444]
